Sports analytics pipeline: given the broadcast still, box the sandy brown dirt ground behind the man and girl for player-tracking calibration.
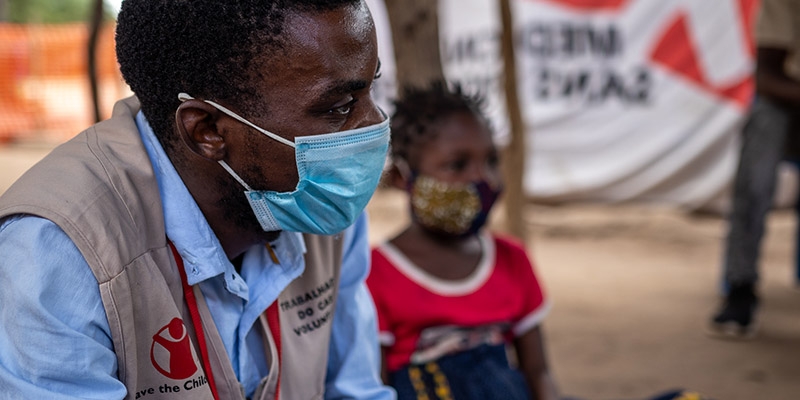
[0,145,800,400]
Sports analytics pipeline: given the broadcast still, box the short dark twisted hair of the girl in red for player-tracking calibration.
[391,81,491,163]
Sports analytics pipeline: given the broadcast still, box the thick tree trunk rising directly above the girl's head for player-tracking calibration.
[385,0,444,96]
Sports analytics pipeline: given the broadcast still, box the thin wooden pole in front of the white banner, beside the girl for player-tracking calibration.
[499,0,527,241]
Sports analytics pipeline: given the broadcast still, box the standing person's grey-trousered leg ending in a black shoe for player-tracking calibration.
[712,99,789,336]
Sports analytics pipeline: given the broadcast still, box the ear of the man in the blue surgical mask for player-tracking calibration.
[175,99,226,161]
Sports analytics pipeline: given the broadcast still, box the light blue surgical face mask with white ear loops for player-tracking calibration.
[178,93,389,235]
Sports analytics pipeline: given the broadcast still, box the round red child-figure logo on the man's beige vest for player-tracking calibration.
[150,318,197,379]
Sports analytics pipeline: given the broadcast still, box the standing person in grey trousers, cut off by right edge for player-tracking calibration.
[711,0,800,338]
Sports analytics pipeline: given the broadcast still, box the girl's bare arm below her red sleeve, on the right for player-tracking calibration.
[514,326,558,400]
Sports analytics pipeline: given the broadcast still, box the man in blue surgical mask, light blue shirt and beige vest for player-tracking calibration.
[0,0,394,399]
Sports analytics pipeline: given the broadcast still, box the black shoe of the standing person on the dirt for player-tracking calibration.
[709,284,758,339]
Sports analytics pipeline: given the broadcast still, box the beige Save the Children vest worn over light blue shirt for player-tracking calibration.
[0,98,342,400]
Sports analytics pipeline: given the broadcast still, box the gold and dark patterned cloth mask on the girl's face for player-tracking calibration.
[409,175,501,237]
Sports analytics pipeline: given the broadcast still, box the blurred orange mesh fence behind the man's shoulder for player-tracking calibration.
[0,24,130,142]
